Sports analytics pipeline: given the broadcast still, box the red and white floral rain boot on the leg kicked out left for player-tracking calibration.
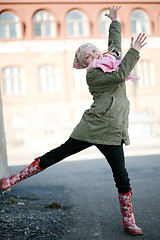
[0,157,44,191]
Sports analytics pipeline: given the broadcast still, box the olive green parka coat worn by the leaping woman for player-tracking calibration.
[70,21,139,145]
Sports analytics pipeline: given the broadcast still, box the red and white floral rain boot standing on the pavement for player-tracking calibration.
[118,188,142,235]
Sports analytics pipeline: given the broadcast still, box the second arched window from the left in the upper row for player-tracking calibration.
[33,10,56,37]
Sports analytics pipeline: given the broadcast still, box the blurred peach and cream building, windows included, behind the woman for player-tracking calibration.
[0,0,160,166]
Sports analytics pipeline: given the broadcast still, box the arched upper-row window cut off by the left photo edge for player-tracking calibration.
[0,11,20,39]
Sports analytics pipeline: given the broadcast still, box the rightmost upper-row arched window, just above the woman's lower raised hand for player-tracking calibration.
[130,9,150,34]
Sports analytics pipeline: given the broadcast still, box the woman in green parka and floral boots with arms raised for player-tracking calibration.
[0,6,146,235]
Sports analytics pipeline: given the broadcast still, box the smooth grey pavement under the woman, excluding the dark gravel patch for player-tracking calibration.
[4,155,160,240]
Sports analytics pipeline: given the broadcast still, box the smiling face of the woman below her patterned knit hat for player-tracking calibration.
[84,47,103,65]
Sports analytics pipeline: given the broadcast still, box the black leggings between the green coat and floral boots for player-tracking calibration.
[39,138,130,193]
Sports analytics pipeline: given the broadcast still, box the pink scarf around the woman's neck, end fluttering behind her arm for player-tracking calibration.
[87,53,139,83]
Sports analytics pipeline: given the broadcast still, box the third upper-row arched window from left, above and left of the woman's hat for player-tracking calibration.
[66,10,89,37]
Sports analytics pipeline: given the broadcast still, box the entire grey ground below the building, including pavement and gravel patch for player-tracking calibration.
[0,155,160,240]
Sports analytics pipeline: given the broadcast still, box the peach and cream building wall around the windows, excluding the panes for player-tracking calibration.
[0,0,160,154]
